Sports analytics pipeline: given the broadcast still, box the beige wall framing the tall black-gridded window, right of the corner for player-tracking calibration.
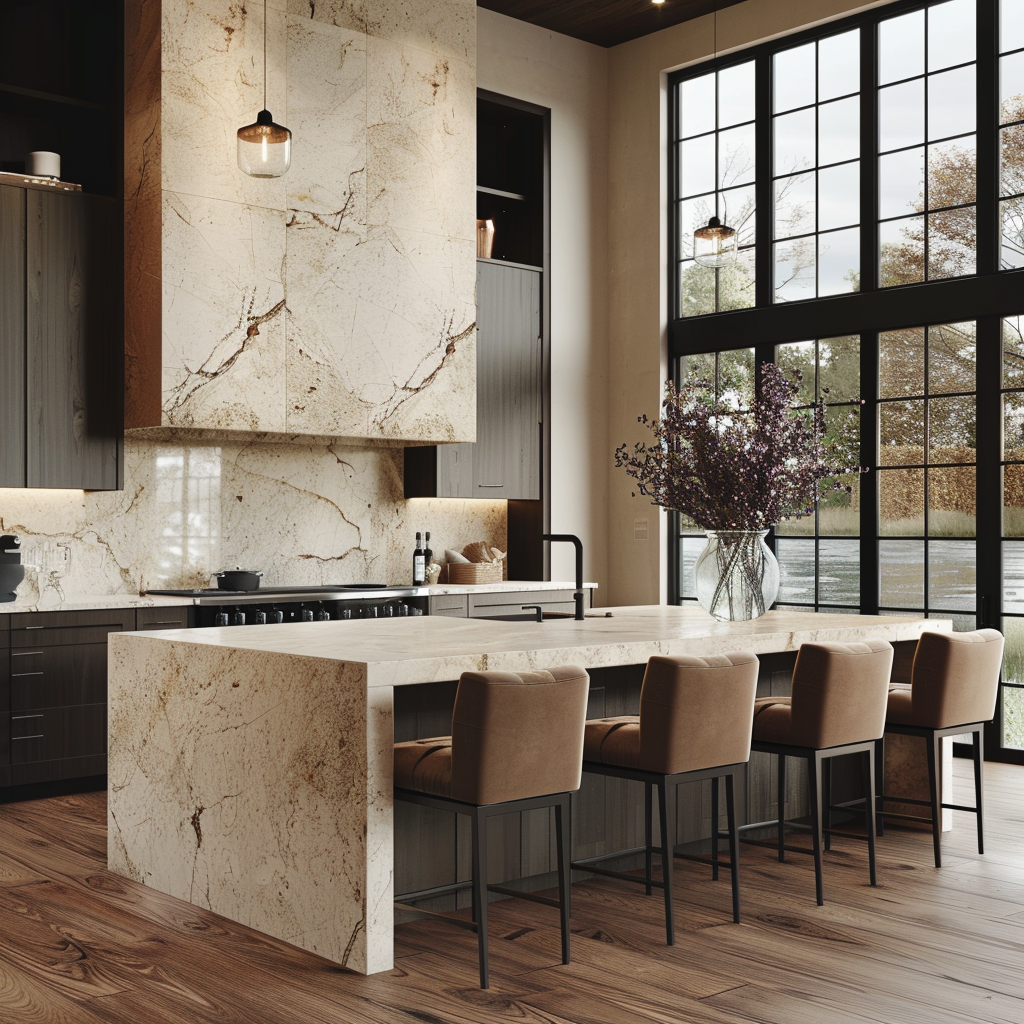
[602,0,897,604]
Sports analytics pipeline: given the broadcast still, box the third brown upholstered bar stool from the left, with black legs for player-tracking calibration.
[744,640,893,906]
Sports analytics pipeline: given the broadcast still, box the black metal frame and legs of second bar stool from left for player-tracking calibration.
[572,761,746,946]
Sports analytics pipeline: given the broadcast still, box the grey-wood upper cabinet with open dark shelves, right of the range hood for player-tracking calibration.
[404,94,548,501]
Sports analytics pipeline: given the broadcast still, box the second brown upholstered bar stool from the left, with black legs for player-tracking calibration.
[572,653,758,946]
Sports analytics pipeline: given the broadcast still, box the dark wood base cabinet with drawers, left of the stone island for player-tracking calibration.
[0,608,133,786]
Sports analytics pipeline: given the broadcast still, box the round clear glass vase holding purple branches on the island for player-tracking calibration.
[693,529,778,623]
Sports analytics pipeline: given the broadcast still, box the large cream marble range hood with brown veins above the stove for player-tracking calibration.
[125,0,476,443]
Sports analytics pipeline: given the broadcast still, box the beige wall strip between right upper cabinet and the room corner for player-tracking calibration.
[476,7,610,604]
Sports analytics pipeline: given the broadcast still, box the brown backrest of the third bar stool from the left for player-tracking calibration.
[792,640,893,749]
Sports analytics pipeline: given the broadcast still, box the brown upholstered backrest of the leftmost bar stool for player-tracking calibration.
[452,665,590,805]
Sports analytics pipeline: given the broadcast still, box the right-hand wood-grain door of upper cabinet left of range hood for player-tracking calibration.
[26,189,122,490]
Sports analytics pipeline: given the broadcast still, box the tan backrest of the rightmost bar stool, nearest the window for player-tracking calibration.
[910,630,1002,729]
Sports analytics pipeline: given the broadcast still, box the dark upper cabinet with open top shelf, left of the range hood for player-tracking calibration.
[0,0,124,489]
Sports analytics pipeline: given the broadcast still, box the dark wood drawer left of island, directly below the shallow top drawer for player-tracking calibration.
[10,642,106,714]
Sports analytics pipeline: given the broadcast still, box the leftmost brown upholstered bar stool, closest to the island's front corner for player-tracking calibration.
[394,666,590,988]
